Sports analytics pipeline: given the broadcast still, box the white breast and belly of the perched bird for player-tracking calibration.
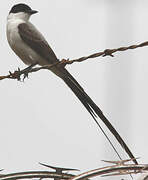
[7,22,41,65]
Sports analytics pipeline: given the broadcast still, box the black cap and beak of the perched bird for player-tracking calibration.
[9,3,38,14]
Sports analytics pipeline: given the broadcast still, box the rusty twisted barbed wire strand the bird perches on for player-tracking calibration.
[0,41,148,80]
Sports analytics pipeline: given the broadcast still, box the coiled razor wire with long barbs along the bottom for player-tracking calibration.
[0,159,148,180]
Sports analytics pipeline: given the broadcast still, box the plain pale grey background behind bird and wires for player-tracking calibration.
[0,0,148,178]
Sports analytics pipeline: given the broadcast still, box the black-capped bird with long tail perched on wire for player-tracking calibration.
[7,4,137,164]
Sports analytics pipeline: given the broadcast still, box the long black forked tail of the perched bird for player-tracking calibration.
[62,70,138,164]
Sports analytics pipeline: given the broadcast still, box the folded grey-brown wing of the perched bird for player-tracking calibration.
[18,23,58,64]
